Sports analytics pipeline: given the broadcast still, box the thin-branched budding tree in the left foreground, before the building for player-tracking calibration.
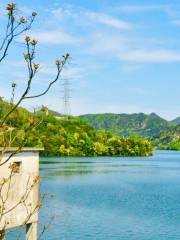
[0,3,70,239]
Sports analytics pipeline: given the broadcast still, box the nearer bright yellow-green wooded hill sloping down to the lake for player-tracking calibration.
[0,101,152,156]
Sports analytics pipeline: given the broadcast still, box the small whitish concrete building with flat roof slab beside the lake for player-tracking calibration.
[0,148,43,240]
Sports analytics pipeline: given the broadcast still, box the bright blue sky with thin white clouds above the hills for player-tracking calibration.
[0,0,180,119]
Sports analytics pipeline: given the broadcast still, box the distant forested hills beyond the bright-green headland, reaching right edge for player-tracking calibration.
[80,113,180,150]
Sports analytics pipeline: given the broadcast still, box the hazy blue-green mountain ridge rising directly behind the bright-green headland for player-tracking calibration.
[80,113,175,141]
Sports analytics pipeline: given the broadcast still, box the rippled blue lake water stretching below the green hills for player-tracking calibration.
[7,151,180,240]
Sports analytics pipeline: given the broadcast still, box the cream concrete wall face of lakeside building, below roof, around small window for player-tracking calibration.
[0,151,39,230]
